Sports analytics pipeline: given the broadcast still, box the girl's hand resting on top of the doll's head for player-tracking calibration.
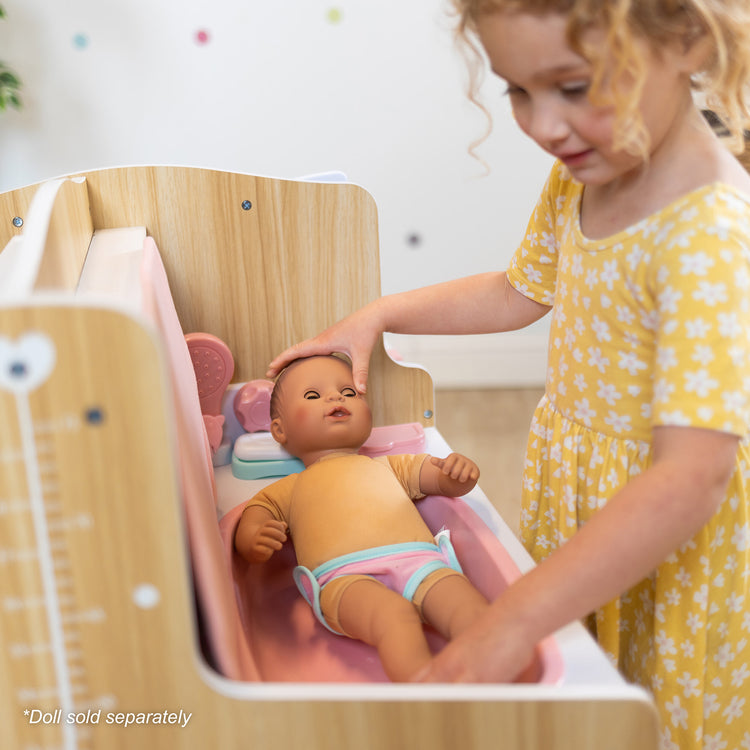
[266,300,384,393]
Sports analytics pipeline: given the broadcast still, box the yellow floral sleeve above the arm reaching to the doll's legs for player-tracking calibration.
[648,190,750,436]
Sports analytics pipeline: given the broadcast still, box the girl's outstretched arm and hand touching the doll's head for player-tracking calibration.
[267,272,550,392]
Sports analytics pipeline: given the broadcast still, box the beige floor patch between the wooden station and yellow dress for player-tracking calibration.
[435,388,543,533]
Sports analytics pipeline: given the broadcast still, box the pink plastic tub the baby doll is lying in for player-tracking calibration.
[220,496,562,683]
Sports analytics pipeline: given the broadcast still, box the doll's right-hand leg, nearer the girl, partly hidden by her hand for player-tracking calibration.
[417,575,489,640]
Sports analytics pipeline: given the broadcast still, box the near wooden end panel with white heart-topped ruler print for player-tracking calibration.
[0,306,656,750]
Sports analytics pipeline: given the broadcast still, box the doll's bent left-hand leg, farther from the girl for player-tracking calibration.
[338,578,432,682]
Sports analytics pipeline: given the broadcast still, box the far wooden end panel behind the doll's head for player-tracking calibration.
[0,167,434,425]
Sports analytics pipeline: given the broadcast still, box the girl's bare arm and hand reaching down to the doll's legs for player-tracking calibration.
[420,427,739,682]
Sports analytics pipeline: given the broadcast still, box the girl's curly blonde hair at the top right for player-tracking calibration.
[452,0,750,155]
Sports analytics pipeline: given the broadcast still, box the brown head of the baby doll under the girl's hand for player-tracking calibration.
[271,355,372,466]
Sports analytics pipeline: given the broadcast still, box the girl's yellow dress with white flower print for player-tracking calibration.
[508,165,750,750]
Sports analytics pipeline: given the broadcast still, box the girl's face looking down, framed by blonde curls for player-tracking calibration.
[477,11,689,185]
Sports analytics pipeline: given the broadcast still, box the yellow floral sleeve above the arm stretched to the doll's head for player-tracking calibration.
[507,163,580,307]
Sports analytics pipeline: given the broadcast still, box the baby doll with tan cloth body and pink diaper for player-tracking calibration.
[234,356,488,681]
